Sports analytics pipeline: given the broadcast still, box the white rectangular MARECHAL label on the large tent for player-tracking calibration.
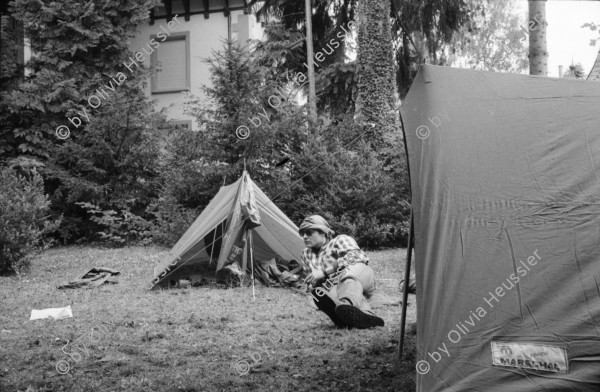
[492,342,569,373]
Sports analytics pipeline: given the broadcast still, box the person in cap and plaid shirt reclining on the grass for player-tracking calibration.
[299,215,384,329]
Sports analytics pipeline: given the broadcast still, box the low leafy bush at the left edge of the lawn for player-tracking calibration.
[0,168,60,275]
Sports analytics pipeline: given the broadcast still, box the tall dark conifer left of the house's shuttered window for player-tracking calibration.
[0,0,169,241]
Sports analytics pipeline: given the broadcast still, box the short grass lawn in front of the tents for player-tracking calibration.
[0,247,416,392]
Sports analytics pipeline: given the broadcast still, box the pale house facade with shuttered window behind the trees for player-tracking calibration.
[130,0,263,130]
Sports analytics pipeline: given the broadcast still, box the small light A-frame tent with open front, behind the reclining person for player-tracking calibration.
[150,171,304,287]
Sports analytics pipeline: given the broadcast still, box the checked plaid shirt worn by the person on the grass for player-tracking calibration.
[301,234,369,275]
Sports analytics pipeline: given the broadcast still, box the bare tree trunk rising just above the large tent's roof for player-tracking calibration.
[527,0,548,76]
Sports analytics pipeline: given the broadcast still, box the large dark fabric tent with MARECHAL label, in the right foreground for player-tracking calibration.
[402,65,600,392]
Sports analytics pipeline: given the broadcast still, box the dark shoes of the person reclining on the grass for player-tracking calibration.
[314,295,384,329]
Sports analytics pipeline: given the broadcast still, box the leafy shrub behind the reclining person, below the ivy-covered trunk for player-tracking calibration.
[276,121,410,250]
